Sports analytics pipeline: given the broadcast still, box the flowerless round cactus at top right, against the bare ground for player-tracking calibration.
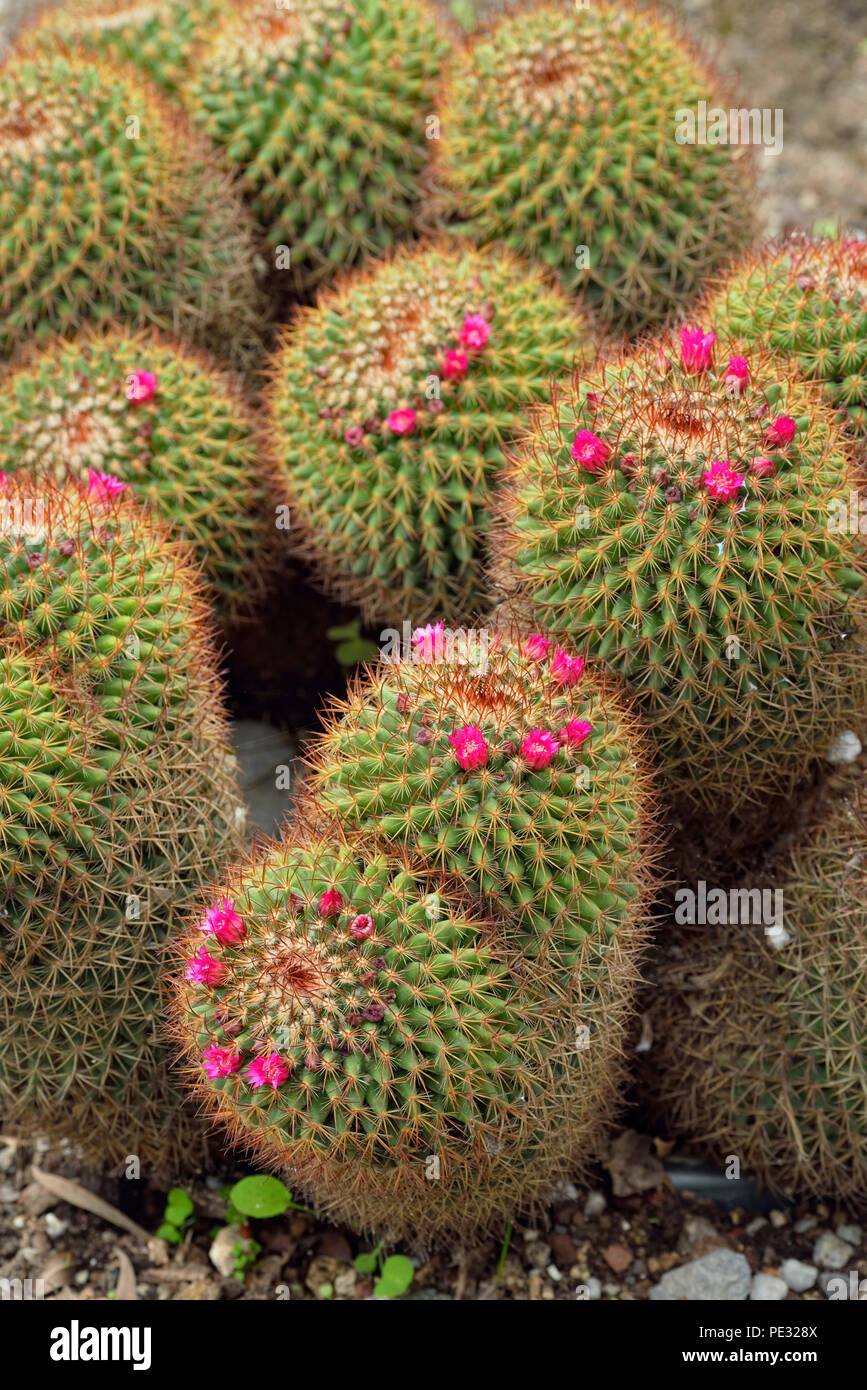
[432,0,750,332]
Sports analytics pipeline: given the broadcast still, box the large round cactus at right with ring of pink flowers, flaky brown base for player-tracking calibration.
[495,328,866,812]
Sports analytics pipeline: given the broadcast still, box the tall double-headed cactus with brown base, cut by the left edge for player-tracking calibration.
[0,477,240,1172]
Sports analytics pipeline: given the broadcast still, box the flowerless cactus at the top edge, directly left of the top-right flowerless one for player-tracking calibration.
[185,0,443,285]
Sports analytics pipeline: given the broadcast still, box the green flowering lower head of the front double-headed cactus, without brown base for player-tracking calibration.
[171,833,531,1163]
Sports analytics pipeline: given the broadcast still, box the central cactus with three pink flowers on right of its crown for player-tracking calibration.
[268,246,589,623]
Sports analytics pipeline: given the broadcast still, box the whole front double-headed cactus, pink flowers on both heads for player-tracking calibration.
[175,626,652,1240]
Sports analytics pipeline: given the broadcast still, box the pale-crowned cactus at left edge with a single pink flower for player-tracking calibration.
[0,328,272,617]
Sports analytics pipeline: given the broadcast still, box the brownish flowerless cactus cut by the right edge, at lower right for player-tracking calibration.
[643,773,867,1198]
